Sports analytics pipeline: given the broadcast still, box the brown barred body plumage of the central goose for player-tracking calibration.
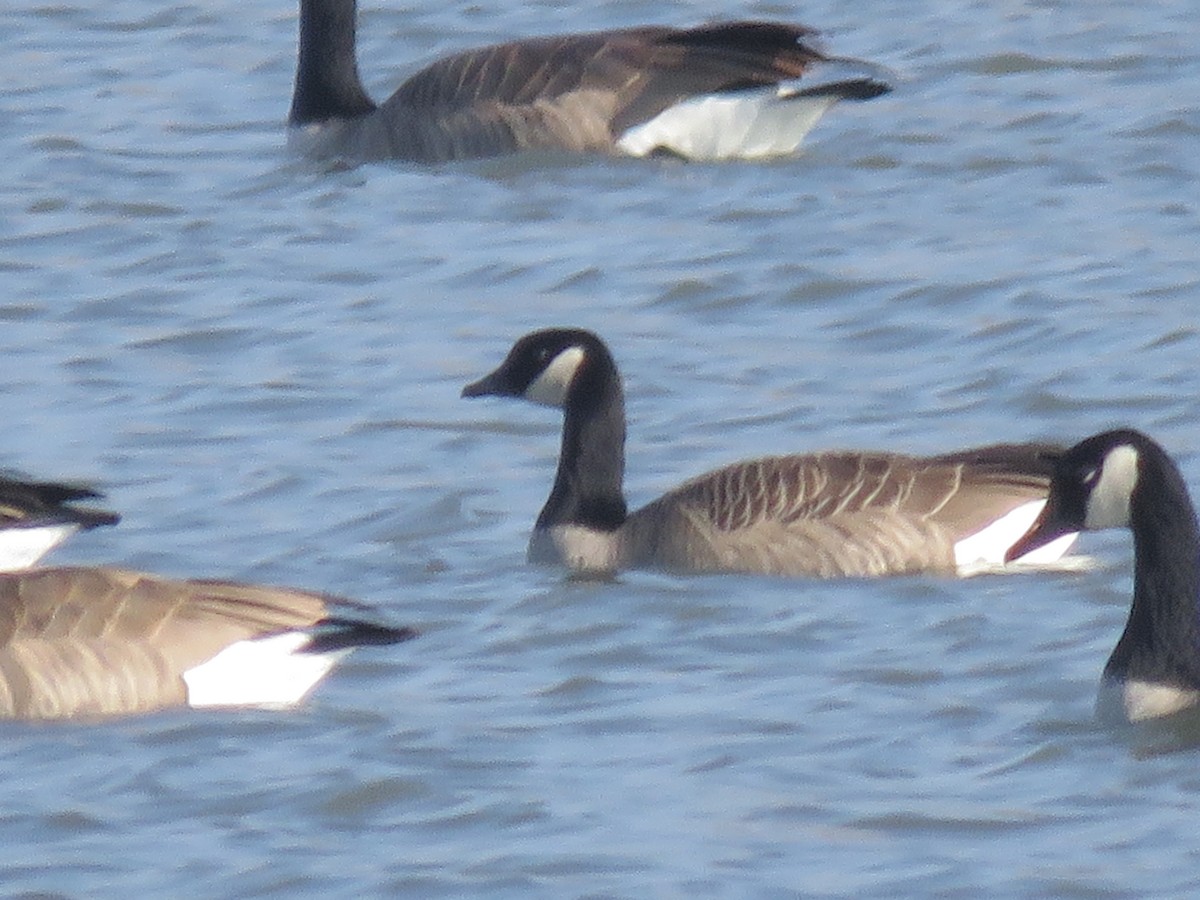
[617,444,1049,577]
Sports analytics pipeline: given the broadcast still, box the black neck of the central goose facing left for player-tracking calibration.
[538,354,625,532]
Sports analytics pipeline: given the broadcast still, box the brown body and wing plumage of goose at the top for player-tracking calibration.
[380,23,823,158]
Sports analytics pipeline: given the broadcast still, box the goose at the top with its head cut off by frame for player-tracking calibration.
[288,0,890,163]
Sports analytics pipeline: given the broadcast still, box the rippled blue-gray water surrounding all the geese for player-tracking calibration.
[0,0,1200,898]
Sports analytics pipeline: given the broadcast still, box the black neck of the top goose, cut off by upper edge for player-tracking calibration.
[288,0,376,125]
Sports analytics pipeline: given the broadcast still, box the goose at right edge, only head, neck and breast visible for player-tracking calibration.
[1009,430,1200,722]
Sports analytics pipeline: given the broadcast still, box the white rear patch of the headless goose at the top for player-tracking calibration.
[617,85,838,160]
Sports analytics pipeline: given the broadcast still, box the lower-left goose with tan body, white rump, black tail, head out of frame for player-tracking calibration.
[0,568,415,719]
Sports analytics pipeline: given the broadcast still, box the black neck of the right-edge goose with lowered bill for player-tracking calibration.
[1104,450,1200,689]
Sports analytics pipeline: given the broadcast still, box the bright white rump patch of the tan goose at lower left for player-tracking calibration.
[184,631,352,707]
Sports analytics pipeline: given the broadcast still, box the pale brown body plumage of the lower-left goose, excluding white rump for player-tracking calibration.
[0,568,412,719]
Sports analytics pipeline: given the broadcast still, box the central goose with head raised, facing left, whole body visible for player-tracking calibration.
[462,328,1074,577]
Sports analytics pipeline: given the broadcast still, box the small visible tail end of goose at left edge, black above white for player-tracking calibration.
[0,475,121,571]
